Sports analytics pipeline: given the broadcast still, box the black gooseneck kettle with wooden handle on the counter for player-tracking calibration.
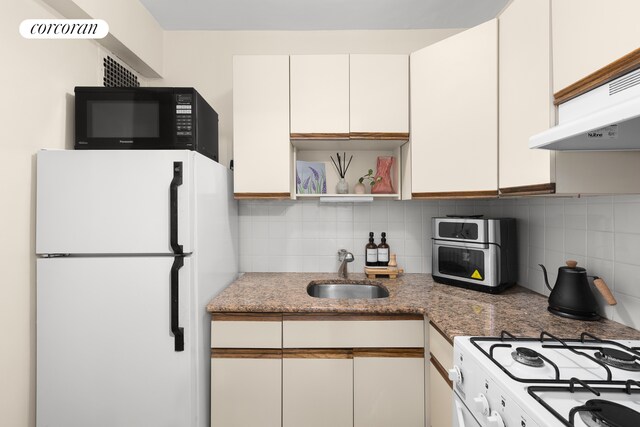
[538,260,616,320]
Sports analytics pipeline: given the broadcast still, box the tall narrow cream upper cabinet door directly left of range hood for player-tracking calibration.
[498,0,555,193]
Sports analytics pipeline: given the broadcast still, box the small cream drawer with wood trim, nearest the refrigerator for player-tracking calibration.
[211,313,282,348]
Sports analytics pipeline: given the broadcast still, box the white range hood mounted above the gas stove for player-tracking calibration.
[529,69,640,151]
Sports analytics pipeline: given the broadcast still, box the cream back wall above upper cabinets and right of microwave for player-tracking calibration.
[163,29,460,166]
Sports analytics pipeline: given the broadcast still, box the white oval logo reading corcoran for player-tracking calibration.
[20,19,109,39]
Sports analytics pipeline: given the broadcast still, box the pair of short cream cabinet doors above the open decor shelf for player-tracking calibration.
[291,55,409,141]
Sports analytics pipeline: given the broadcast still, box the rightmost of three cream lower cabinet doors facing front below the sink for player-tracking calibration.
[353,353,425,427]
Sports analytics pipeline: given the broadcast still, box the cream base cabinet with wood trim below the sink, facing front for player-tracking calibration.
[211,314,426,427]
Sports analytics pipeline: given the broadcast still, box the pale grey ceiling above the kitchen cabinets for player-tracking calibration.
[140,0,509,30]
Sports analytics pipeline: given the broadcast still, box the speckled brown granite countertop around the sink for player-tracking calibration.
[207,273,640,340]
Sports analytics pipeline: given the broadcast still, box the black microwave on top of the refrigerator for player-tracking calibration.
[74,86,218,161]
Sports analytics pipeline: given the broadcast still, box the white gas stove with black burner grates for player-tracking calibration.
[449,332,640,427]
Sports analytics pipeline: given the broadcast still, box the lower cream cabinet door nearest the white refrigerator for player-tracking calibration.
[211,356,282,427]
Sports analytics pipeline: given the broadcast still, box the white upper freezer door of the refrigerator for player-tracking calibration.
[36,150,194,254]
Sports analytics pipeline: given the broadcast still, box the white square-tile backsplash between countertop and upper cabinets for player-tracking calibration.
[239,196,640,329]
